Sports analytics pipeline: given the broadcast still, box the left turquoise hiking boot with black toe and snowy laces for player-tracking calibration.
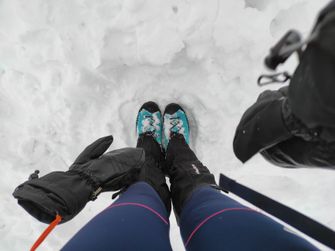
[136,101,162,146]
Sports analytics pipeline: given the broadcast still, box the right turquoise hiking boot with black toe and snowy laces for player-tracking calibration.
[163,103,190,151]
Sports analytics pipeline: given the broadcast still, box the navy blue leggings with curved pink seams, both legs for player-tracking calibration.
[62,182,317,251]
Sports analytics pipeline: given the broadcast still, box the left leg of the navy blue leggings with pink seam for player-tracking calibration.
[62,182,172,251]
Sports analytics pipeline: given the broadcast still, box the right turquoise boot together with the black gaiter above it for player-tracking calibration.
[163,103,217,220]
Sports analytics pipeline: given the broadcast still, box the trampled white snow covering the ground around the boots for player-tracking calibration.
[0,0,335,250]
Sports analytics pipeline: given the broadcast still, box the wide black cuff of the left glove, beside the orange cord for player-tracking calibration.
[13,172,93,223]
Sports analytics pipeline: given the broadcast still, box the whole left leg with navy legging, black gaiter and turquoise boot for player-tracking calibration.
[64,102,171,250]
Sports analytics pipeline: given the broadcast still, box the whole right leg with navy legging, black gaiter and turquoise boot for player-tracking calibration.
[164,102,317,251]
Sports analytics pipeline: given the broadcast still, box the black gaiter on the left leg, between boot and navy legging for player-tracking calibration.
[136,135,171,212]
